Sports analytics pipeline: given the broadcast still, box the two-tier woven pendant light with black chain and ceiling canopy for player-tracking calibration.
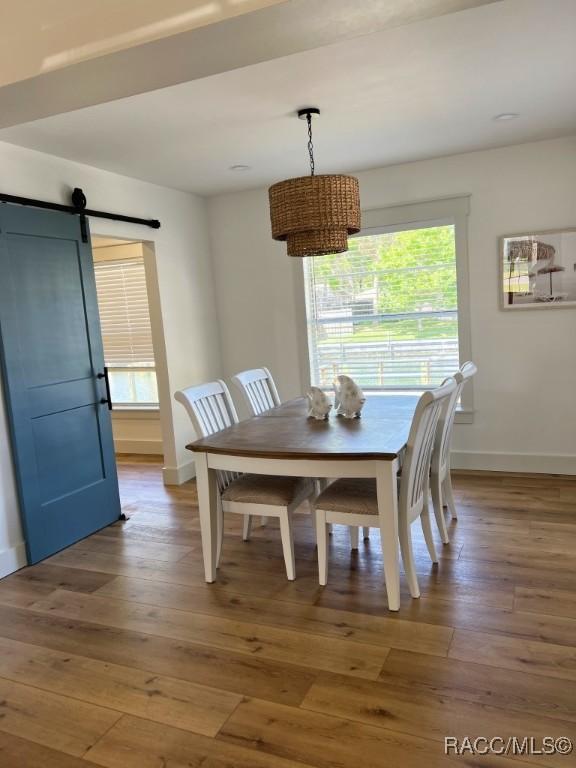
[268,107,360,256]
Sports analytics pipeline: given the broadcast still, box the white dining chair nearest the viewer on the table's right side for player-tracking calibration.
[314,379,456,597]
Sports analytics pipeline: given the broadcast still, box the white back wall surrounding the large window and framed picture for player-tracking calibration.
[209,138,576,473]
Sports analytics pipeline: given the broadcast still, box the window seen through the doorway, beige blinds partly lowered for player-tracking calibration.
[94,256,158,407]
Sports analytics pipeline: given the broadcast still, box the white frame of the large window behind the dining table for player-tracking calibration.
[293,195,474,423]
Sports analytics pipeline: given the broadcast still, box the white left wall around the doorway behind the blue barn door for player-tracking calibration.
[0,136,221,573]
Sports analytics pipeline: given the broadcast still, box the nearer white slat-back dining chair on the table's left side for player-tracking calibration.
[174,379,314,581]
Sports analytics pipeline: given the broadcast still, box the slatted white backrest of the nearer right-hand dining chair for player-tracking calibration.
[399,378,456,522]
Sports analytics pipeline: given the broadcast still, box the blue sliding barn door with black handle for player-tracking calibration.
[0,203,120,563]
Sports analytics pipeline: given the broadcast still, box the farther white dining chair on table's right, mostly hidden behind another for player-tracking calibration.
[430,361,478,544]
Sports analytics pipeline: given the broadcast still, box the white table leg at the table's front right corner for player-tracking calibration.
[376,461,400,611]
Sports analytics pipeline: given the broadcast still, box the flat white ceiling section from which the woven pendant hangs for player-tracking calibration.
[0,0,576,194]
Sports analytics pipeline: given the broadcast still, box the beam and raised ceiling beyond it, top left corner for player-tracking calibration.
[0,0,502,128]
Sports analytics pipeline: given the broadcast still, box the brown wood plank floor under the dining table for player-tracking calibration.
[0,457,576,768]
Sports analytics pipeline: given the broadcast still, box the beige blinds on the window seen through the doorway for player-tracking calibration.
[94,258,154,368]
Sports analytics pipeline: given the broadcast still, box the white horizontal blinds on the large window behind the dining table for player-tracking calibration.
[304,224,459,390]
